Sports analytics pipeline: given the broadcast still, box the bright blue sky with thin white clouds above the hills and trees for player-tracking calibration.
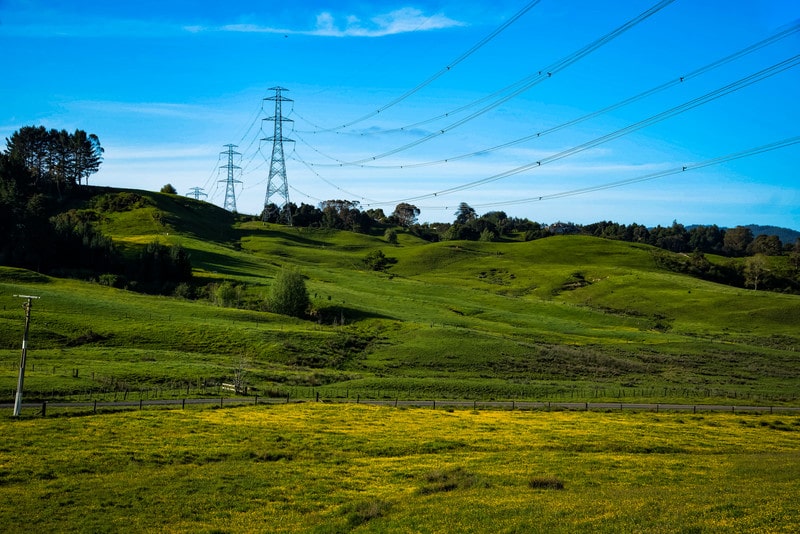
[0,0,800,229]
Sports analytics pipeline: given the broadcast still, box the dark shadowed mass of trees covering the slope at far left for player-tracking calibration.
[0,126,192,293]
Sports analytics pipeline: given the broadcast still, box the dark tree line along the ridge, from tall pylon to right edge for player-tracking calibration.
[262,200,800,293]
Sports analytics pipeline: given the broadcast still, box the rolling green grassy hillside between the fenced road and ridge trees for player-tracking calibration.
[0,191,800,402]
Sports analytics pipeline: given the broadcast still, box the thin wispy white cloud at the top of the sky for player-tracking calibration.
[216,7,465,37]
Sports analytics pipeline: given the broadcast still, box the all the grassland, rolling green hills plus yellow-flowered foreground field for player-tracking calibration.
[0,192,800,533]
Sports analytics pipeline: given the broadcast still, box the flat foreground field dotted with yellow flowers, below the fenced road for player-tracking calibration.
[0,403,800,533]
